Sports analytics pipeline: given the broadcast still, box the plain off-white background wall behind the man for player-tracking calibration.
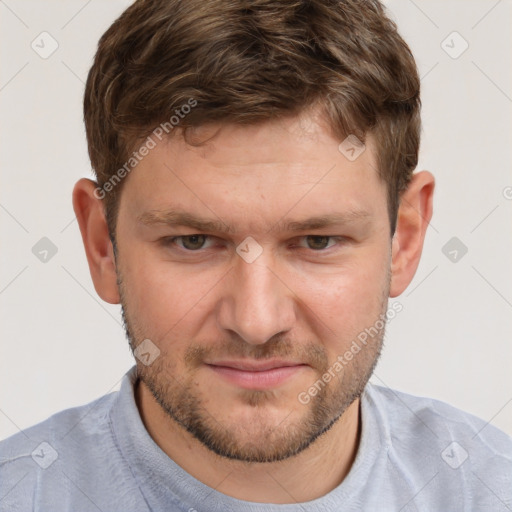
[0,0,512,438]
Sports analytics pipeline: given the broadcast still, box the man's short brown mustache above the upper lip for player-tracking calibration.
[184,338,329,371]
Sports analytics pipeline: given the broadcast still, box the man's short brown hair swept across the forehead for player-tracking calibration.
[84,0,420,241]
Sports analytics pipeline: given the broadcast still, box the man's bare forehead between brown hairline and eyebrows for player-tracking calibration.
[120,115,386,234]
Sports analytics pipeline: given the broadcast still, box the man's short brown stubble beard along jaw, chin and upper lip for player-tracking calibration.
[118,272,389,463]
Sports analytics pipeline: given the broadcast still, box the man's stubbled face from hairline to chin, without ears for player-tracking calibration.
[116,114,391,462]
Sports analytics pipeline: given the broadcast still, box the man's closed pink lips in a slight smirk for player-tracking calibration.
[206,360,309,390]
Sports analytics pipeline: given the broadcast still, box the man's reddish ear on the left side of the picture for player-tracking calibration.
[73,178,120,304]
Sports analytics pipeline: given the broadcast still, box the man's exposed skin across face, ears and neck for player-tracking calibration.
[73,111,434,503]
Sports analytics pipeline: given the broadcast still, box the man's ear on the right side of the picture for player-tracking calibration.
[389,171,435,297]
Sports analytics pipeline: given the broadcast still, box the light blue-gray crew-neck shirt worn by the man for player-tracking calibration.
[0,368,512,512]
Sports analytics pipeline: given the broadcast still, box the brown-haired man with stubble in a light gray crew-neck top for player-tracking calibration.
[0,0,512,512]
